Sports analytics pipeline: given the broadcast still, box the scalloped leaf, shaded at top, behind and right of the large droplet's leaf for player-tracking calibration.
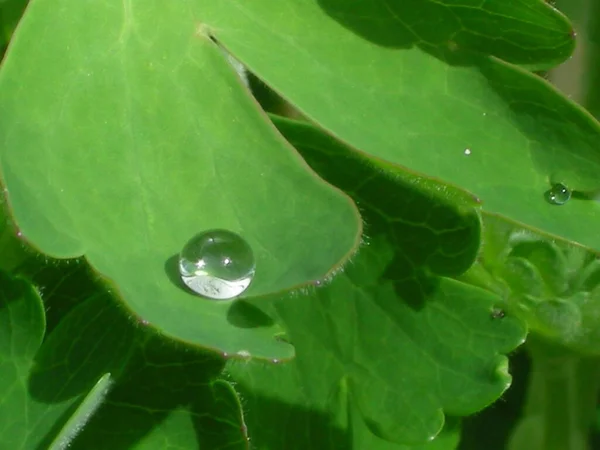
[229,118,525,449]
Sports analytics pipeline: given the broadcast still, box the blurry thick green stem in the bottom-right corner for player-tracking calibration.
[511,338,600,450]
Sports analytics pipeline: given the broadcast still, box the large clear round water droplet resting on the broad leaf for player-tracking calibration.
[179,230,255,300]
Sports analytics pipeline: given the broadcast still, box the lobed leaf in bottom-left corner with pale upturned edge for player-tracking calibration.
[0,290,132,449]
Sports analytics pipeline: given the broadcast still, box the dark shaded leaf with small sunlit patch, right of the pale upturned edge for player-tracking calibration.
[72,334,249,450]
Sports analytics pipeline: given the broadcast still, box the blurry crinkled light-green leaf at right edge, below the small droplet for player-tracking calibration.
[461,216,600,355]
